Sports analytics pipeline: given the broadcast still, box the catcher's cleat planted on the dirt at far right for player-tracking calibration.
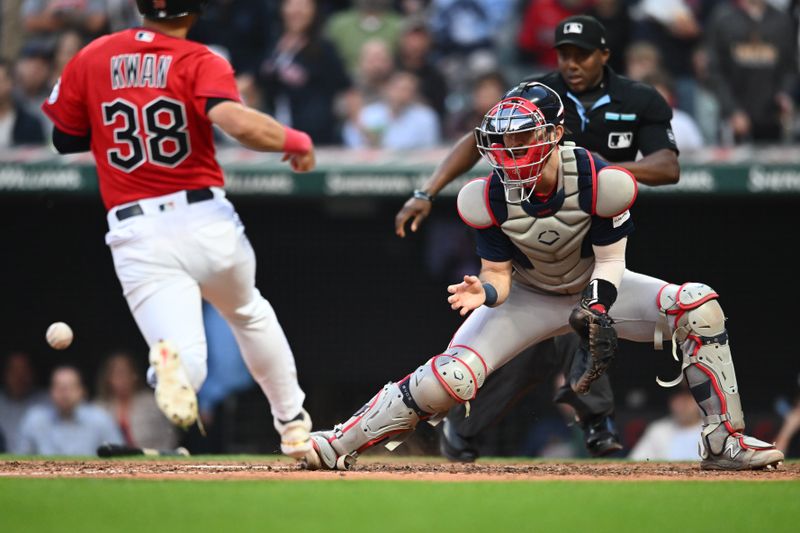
[700,433,783,470]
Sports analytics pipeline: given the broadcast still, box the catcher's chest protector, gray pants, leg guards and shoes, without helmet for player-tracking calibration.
[307,141,783,469]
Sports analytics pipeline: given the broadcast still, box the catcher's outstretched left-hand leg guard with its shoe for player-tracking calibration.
[306,347,486,469]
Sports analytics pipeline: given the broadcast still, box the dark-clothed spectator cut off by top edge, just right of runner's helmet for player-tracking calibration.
[189,0,280,78]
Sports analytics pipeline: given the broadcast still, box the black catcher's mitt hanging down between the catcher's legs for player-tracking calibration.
[569,279,617,394]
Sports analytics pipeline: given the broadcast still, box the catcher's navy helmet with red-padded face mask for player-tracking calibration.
[475,82,564,203]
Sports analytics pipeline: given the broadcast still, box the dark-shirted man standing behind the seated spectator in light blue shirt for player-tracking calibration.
[397,16,447,120]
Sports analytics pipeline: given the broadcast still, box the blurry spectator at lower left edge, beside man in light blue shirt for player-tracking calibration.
[0,352,47,451]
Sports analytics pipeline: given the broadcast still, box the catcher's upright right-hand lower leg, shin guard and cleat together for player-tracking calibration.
[657,283,783,470]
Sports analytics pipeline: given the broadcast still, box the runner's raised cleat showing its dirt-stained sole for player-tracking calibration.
[150,341,198,429]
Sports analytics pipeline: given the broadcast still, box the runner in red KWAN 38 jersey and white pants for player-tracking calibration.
[42,0,315,458]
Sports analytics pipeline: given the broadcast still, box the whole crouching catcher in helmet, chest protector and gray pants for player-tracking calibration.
[306,82,783,470]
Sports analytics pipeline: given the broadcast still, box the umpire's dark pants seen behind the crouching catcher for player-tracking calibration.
[447,333,614,438]
